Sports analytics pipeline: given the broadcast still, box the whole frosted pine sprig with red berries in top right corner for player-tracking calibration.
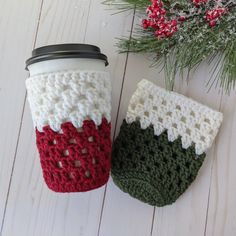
[106,0,236,91]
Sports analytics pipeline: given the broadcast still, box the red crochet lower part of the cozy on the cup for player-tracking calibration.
[36,118,111,192]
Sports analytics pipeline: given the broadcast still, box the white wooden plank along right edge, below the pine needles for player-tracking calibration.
[205,91,236,236]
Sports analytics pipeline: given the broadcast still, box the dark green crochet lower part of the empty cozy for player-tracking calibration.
[111,120,205,206]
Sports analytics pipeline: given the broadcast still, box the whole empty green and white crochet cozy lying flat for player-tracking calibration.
[111,80,223,206]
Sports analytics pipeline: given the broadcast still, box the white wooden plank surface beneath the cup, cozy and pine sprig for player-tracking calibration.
[0,0,236,236]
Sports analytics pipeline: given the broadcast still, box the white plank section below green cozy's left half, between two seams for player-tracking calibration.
[99,180,153,236]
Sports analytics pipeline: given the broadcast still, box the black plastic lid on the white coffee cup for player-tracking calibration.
[26,44,108,70]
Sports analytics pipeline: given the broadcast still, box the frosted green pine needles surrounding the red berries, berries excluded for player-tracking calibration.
[105,0,236,92]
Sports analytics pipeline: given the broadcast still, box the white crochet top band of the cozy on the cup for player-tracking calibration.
[26,71,111,131]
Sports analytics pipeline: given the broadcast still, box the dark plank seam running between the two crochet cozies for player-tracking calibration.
[97,8,136,236]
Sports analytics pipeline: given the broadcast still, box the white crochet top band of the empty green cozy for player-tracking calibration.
[126,80,223,155]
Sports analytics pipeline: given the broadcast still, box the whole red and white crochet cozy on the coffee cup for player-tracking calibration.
[26,71,111,192]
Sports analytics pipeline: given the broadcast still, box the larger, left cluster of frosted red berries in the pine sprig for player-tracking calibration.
[142,0,178,38]
